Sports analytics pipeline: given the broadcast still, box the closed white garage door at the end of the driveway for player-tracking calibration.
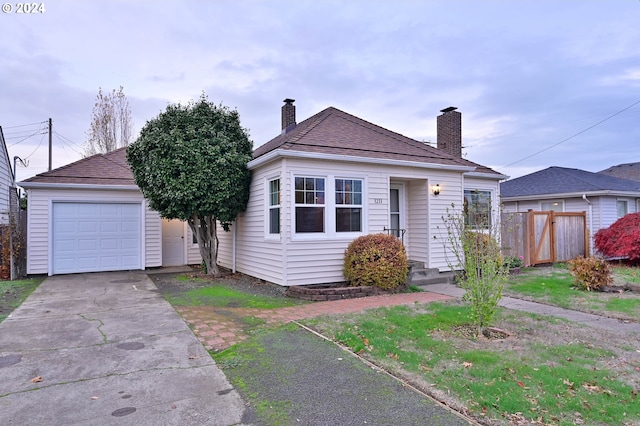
[53,202,142,274]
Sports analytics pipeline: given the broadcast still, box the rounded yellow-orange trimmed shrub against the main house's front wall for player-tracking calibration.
[342,234,409,290]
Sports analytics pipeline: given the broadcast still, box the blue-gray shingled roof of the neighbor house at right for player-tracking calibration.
[500,167,640,199]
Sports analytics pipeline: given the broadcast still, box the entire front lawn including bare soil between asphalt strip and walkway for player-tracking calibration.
[303,302,640,425]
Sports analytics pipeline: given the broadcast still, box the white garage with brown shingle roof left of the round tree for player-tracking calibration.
[20,148,168,275]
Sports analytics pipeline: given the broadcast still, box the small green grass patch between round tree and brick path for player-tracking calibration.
[165,283,301,309]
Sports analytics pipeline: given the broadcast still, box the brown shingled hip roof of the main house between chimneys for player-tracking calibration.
[253,107,505,179]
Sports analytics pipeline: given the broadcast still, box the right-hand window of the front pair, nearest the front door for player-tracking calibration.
[335,179,362,232]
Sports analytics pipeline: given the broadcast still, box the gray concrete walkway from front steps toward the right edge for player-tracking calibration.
[421,284,640,334]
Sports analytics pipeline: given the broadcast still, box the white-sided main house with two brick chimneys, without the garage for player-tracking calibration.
[214,99,506,286]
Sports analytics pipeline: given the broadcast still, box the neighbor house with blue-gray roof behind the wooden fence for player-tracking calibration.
[500,167,640,253]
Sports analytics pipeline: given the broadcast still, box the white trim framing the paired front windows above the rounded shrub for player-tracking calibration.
[292,170,369,241]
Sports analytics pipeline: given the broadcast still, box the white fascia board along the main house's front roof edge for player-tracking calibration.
[247,149,476,172]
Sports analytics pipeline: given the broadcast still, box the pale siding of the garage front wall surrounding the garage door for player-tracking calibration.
[27,188,162,274]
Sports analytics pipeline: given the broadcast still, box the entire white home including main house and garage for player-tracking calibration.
[21,99,506,286]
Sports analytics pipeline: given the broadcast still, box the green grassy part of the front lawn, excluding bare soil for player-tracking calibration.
[305,304,640,425]
